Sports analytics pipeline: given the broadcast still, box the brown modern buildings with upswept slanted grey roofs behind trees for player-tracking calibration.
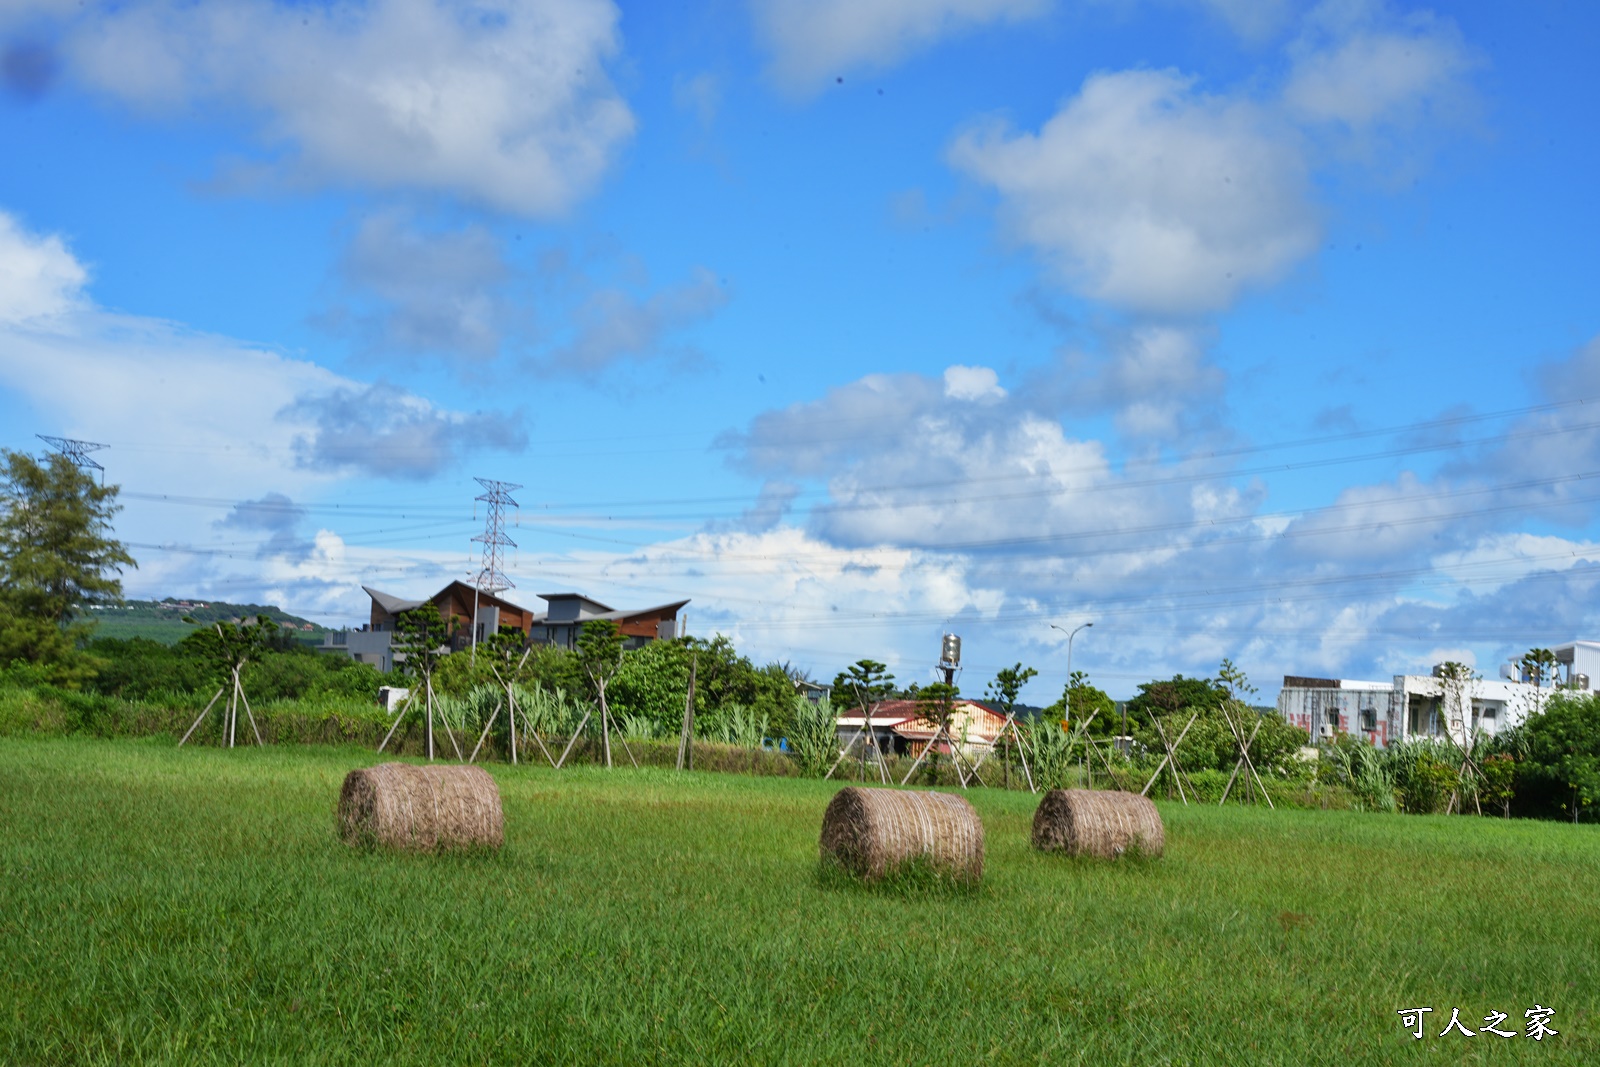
[322,581,688,670]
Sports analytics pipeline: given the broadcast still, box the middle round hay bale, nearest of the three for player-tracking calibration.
[822,785,984,883]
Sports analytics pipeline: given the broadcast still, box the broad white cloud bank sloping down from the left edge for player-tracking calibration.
[0,213,520,541]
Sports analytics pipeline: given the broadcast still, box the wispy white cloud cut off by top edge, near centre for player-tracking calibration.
[752,0,1050,93]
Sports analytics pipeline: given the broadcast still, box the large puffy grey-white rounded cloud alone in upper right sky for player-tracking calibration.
[949,70,1320,315]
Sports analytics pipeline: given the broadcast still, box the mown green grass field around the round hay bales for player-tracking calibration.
[0,739,1600,1065]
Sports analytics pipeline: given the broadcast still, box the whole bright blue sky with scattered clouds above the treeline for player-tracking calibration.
[0,0,1600,702]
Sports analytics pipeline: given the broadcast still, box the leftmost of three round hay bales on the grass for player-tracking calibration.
[339,763,506,853]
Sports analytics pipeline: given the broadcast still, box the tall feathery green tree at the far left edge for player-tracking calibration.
[0,451,138,629]
